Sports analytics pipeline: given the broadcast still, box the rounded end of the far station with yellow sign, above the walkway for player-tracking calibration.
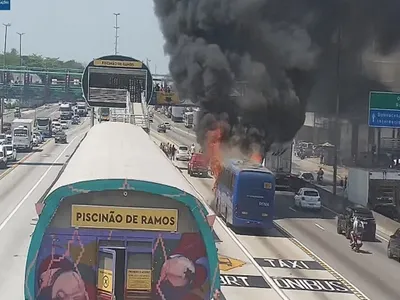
[82,55,153,108]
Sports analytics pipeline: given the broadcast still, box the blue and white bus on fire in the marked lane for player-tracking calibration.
[216,160,275,229]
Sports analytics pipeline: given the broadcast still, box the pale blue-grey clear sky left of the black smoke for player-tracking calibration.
[0,0,169,74]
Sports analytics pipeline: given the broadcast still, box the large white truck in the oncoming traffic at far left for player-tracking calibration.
[11,119,34,151]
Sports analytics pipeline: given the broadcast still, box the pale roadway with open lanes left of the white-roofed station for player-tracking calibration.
[0,120,89,299]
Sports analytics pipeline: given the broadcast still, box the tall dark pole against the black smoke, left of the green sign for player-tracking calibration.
[332,24,342,195]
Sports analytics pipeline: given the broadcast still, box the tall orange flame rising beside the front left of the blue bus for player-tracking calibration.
[207,127,222,190]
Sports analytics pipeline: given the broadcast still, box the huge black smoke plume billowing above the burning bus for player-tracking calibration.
[154,0,400,150]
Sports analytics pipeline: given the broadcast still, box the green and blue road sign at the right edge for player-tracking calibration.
[368,92,400,128]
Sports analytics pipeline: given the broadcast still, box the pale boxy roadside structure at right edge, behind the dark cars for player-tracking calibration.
[346,168,400,219]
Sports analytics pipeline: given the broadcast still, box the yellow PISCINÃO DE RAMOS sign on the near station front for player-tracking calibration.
[71,205,178,232]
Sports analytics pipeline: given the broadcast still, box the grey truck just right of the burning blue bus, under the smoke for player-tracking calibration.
[263,142,293,191]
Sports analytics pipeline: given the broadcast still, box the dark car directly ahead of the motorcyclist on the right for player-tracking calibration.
[337,205,376,241]
